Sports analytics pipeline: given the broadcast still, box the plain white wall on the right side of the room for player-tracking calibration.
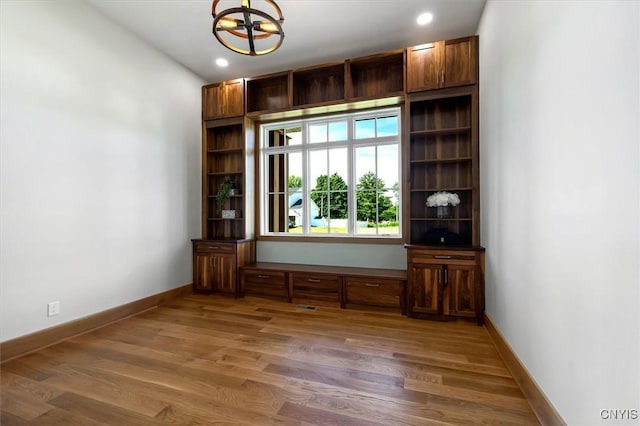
[478,1,640,425]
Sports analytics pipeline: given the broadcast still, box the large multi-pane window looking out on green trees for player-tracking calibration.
[260,108,402,238]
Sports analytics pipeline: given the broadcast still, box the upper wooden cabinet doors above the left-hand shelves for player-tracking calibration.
[202,79,244,120]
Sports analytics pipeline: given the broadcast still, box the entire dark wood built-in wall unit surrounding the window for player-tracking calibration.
[198,36,484,324]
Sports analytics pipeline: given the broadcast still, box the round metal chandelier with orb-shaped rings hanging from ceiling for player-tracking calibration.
[211,0,284,56]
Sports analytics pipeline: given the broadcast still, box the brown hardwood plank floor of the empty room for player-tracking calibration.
[0,295,538,426]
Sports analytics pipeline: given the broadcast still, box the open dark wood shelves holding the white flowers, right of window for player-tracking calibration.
[408,89,479,244]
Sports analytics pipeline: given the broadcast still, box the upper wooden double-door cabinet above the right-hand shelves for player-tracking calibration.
[407,36,477,92]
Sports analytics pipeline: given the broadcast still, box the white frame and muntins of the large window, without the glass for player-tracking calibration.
[256,106,404,244]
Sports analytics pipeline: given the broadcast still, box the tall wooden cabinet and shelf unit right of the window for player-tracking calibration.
[405,37,484,324]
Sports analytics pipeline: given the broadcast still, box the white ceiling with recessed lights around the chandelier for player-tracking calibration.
[87,0,486,83]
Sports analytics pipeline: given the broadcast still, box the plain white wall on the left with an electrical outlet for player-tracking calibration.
[0,1,203,341]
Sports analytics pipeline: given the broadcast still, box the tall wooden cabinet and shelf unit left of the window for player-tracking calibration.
[192,79,256,296]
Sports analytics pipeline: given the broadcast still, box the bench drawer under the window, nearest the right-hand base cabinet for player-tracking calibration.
[345,277,404,309]
